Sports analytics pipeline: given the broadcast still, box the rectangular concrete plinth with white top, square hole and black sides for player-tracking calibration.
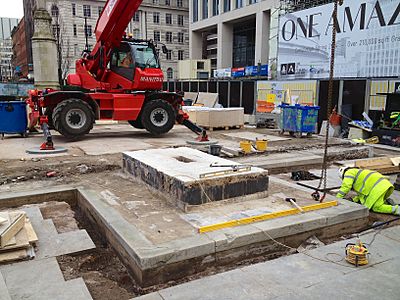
[123,147,268,205]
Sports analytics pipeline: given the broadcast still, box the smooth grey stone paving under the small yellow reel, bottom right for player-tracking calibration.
[136,226,400,300]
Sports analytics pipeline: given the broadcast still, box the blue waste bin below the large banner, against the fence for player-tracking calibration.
[280,104,320,133]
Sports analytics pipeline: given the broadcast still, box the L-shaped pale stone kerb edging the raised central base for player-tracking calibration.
[0,183,369,287]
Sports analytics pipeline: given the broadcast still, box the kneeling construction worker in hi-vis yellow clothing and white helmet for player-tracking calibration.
[336,167,400,215]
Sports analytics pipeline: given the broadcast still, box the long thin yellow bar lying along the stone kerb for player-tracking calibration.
[199,201,338,233]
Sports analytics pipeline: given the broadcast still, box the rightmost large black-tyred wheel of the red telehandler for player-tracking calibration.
[141,99,176,135]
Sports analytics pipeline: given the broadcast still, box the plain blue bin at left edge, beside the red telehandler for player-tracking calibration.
[0,101,28,135]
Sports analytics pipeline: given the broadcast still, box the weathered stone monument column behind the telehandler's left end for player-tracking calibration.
[32,0,60,89]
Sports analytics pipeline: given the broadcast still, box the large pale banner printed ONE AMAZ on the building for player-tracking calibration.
[278,0,400,79]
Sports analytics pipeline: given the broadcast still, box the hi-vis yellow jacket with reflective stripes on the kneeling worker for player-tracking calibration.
[336,168,394,209]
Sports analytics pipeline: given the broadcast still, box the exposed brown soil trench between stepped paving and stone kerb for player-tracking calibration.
[40,202,140,300]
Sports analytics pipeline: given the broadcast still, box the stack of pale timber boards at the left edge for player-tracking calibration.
[0,211,38,263]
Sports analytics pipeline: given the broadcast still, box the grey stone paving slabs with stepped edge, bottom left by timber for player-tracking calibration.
[0,207,95,300]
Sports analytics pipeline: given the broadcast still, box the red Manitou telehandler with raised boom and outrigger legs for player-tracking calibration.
[28,0,206,149]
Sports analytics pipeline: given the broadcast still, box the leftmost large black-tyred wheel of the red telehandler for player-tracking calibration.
[52,99,95,139]
